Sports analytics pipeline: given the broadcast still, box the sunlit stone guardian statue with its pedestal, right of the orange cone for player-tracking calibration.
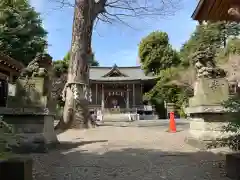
[185,49,232,149]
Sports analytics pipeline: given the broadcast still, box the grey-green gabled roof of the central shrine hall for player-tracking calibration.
[89,64,156,81]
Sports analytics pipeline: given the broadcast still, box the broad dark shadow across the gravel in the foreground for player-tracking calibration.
[32,140,228,180]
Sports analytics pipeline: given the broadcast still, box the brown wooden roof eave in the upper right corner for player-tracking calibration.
[192,0,240,22]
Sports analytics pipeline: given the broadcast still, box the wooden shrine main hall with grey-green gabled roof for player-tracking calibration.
[89,65,156,110]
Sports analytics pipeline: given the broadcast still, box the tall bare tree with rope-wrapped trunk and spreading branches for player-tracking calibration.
[55,0,179,129]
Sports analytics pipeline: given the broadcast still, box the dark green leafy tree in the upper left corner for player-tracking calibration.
[0,0,47,65]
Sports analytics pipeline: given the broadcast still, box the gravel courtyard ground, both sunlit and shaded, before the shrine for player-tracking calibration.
[33,127,228,180]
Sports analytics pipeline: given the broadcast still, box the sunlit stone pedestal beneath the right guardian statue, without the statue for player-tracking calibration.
[185,78,232,149]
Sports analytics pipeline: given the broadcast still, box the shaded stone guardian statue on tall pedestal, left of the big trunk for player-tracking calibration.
[0,53,58,152]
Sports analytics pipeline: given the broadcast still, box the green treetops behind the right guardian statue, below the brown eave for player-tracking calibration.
[180,22,240,66]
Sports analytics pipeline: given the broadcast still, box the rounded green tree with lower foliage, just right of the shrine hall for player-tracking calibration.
[139,31,181,115]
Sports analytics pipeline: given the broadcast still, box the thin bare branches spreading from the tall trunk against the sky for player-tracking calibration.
[48,0,181,28]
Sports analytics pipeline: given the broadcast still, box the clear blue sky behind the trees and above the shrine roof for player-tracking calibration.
[31,0,197,66]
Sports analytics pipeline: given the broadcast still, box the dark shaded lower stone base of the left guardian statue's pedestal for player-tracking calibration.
[3,114,59,153]
